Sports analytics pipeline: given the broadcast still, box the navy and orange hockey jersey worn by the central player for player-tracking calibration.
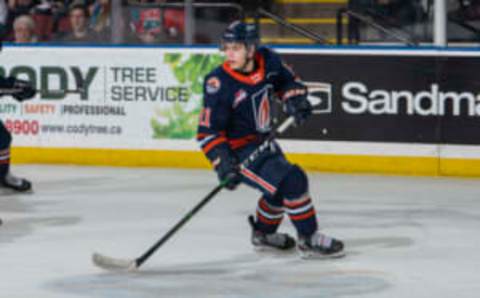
[197,47,297,161]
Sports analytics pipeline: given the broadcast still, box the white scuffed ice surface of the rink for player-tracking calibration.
[0,166,480,298]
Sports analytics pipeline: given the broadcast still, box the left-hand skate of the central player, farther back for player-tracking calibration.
[248,215,296,251]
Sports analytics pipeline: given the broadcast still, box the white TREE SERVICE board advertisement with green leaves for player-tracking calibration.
[0,47,222,150]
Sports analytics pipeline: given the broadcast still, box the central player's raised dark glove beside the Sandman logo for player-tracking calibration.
[283,88,312,125]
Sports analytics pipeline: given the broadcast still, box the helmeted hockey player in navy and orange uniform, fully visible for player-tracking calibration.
[197,21,344,257]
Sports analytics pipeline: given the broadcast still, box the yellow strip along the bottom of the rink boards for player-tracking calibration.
[12,147,480,177]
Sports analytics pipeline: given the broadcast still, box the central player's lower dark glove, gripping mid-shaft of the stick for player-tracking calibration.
[213,150,242,190]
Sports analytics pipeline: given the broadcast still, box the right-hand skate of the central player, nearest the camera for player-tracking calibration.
[297,232,345,259]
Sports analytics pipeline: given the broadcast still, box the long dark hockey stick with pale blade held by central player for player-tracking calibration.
[92,117,295,271]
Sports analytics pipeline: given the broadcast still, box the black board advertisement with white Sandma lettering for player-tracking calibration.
[283,51,480,144]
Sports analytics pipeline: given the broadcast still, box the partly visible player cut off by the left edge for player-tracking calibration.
[0,40,36,192]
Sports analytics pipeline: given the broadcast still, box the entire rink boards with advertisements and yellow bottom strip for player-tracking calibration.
[0,46,480,176]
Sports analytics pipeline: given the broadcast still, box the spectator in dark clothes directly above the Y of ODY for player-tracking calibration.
[59,2,101,43]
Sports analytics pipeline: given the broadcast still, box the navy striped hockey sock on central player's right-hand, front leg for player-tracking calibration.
[279,166,318,236]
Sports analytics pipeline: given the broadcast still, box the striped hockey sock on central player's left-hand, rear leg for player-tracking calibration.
[256,197,283,234]
